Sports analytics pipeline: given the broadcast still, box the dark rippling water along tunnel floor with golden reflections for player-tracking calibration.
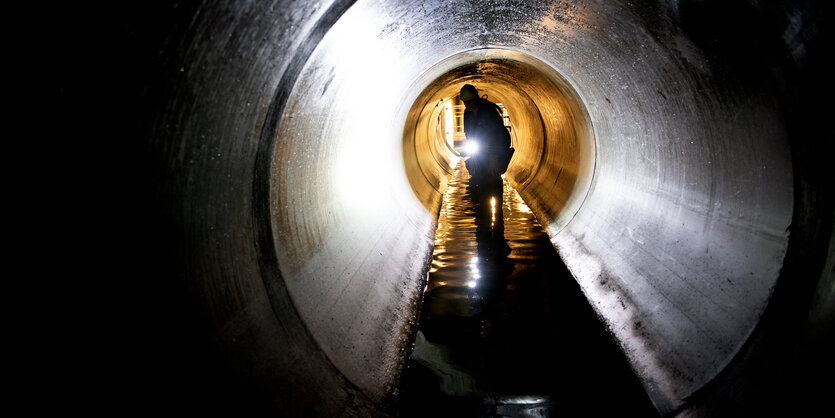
[398,162,658,417]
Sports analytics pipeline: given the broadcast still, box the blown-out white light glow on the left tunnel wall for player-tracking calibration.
[322,8,408,216]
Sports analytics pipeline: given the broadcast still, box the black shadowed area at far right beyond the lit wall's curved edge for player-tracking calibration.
[680,0,835,416]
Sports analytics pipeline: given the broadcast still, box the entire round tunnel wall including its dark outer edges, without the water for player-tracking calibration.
[131,0,835,416]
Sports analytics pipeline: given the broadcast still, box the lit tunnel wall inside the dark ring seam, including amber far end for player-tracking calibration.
[264,0,791,410]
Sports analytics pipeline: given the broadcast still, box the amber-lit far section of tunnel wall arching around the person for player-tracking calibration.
[402,48,596,234]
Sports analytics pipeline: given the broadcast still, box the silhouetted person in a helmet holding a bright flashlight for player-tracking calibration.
[459,84,510,198]
